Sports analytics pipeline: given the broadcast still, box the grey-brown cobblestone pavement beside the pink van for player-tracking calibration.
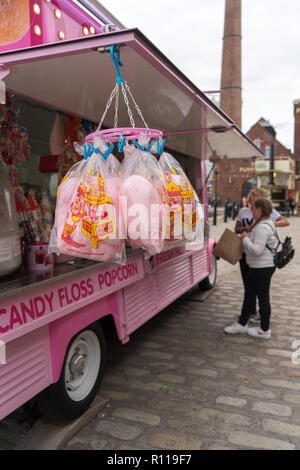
[0,217,300,450]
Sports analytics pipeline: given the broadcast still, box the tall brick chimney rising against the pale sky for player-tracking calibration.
[220,0,242,128]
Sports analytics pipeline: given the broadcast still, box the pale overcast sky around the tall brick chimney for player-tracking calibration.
[100,0,300,150]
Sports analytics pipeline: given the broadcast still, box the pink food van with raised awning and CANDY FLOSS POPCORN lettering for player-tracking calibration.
[0,0,260,420]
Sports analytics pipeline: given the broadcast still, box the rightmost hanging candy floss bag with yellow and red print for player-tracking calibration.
[159,152,200,249]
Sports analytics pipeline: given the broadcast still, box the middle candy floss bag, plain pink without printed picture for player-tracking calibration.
[121,134,165,255]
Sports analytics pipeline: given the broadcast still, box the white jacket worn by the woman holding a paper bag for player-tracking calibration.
[243,218,278,268]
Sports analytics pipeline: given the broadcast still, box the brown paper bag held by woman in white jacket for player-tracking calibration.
[214,228,243,264]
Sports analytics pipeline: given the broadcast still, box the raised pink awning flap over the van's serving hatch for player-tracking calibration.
[0,29,262,162]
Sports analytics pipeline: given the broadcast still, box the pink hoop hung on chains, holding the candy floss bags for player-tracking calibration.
[85,127,163,144]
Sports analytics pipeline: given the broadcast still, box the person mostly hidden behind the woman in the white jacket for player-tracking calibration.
[235,188,290,322]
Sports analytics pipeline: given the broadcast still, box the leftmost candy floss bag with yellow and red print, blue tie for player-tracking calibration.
[50,139,125,263]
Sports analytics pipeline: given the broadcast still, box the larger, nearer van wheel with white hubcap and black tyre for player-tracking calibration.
[39,323,106,421]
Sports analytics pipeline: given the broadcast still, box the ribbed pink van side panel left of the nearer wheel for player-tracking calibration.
[0,326,51,420]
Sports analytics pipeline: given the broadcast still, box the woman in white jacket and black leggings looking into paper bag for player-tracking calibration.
[224,198,278,339]
